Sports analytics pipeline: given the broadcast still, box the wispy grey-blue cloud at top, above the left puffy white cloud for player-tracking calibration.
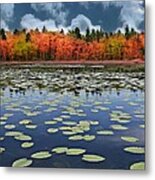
[31,2,68,25]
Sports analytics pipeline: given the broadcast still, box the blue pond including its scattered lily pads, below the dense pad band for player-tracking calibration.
[0,68,145,169]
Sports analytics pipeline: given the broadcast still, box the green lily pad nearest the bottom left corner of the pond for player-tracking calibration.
[12,158,33,168]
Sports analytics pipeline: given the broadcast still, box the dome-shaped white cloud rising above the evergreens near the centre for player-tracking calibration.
[67,14,101,33]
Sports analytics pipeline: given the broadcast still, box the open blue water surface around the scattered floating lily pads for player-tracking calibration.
[0,88,144,169]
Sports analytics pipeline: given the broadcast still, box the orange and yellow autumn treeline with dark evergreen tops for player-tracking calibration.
[0,26,145,61]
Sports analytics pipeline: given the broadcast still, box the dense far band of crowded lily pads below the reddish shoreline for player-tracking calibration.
[0,68,145,94]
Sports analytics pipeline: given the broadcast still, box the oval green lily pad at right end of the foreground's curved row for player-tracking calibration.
[82,154,105,162]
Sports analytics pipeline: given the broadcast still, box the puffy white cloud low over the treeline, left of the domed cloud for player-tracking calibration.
[20,14,57,31]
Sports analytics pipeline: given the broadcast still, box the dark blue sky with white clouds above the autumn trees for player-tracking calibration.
[0,0,145,33]
